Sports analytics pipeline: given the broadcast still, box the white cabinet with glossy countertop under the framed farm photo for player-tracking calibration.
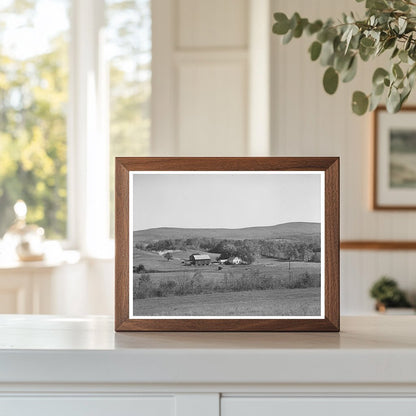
[0,315,416,416]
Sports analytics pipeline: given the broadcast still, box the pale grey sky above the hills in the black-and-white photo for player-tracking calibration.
[132,173,321,231]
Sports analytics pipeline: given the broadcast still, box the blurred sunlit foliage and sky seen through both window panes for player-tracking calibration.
[0,0,151,239]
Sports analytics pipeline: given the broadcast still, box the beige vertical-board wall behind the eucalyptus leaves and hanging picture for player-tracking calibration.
[271,0,416,314]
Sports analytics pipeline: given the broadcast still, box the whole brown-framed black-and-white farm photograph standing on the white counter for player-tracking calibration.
[115,157,339,331]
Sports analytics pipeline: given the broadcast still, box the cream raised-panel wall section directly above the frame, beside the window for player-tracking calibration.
[152,0,270,156]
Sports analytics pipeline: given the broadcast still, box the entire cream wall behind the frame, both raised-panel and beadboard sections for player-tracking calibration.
[44,0,416,314]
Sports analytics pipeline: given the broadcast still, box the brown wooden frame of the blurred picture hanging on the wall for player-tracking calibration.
[372,106,416,211]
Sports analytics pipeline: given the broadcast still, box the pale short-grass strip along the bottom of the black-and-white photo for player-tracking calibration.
[133,288,321,316]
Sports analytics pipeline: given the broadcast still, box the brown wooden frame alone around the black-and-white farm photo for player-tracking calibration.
[115,157,340,331]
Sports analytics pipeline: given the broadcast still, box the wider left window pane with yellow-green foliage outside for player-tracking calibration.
[0,0,70,239]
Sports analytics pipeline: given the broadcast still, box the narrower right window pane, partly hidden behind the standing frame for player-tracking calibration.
[106,0,152,236]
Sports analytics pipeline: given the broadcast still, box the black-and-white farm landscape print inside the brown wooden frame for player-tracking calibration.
[130,172,323,318]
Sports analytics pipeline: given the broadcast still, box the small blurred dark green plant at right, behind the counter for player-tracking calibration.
[370,276,411,312]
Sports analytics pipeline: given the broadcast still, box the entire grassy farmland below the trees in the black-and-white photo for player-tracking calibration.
[133,248,321,316]
